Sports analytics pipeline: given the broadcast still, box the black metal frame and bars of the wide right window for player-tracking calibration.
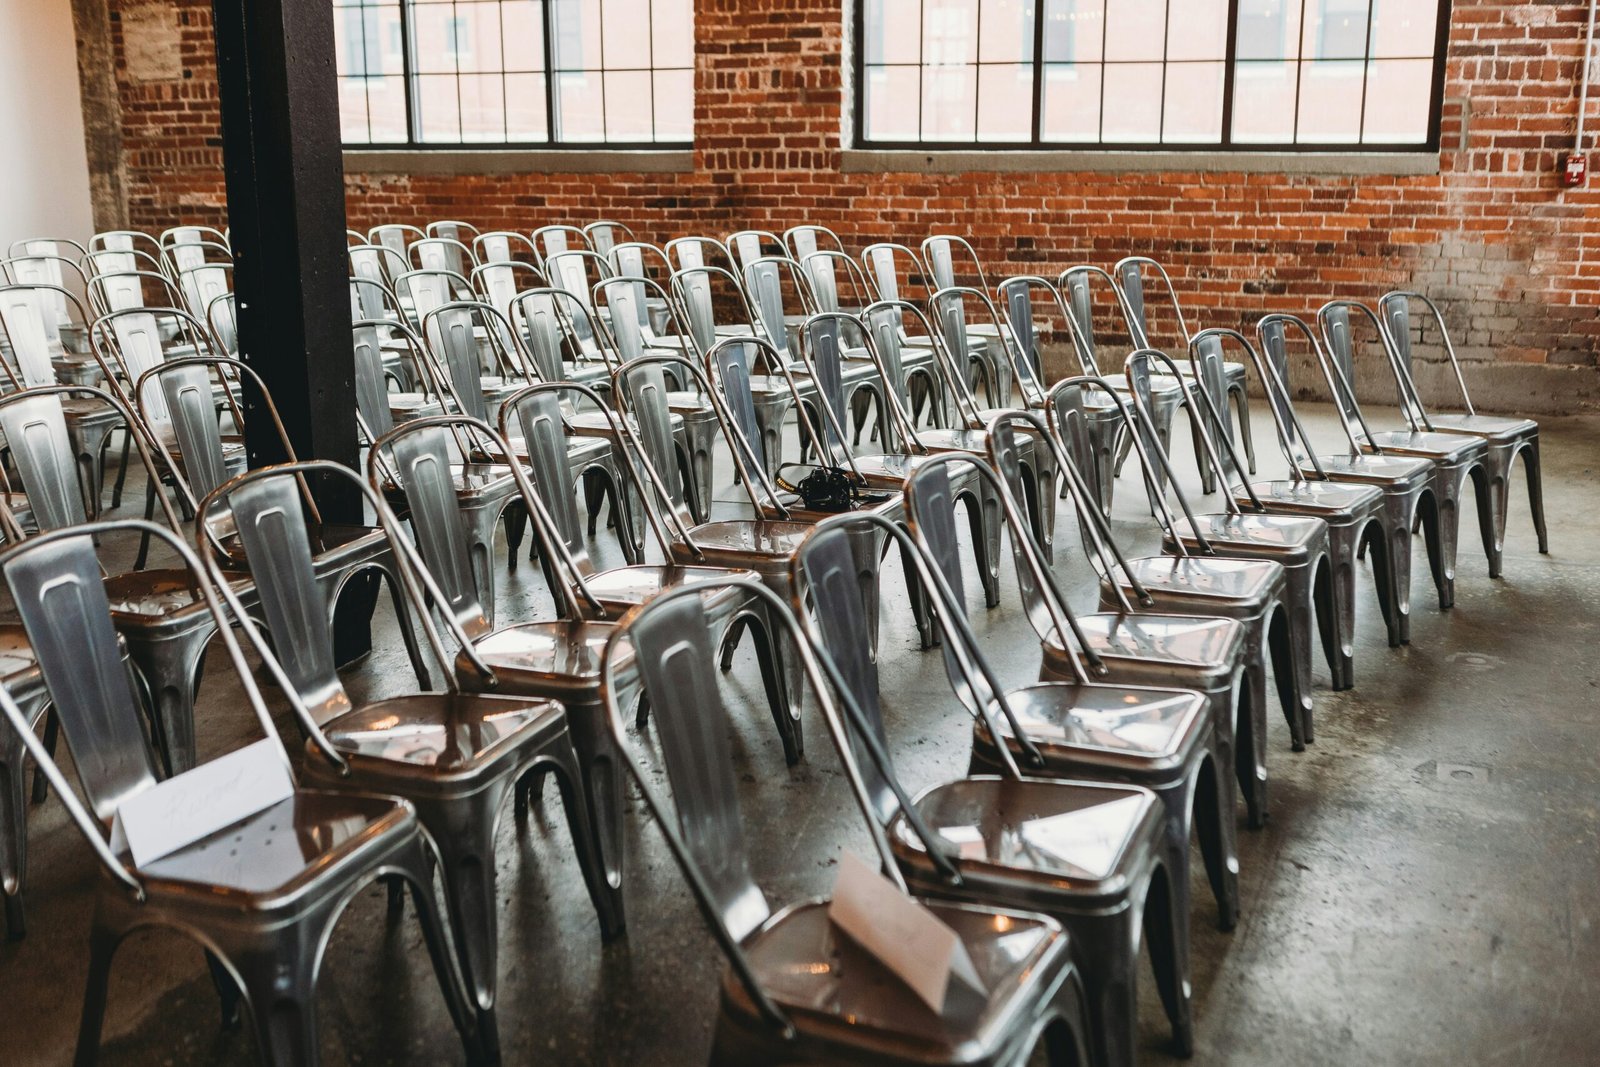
[848,0,1454,155]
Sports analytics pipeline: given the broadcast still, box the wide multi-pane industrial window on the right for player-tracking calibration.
[854,0,1450,150]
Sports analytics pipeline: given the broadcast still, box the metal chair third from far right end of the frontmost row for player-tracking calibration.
[1256,314,1440,648]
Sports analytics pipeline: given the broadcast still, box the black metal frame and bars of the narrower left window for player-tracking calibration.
[340,0,694,154]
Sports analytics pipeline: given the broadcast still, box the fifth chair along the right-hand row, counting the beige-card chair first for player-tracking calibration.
[1050,378,1301,827]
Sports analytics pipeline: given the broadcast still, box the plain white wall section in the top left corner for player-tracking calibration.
[0,0,93,254]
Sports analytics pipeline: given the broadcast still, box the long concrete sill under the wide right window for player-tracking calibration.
[840,149,1438,174]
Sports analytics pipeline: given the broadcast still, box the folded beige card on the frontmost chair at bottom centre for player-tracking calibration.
[827,853,986,1014]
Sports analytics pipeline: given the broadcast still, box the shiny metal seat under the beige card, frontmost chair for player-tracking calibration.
[736,901,1070,1064]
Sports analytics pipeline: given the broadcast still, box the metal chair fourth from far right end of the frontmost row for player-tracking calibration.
[1189,328,1394,689]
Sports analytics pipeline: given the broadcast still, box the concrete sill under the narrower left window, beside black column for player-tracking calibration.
[344,147,694,174]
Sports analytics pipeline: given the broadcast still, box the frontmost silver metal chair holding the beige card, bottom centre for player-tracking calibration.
[605,575,1100,1067]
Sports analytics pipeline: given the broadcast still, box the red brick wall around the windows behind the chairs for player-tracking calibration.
[96,0,1600,375]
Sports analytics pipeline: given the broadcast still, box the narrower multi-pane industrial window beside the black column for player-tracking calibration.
[333,0,694,147]
